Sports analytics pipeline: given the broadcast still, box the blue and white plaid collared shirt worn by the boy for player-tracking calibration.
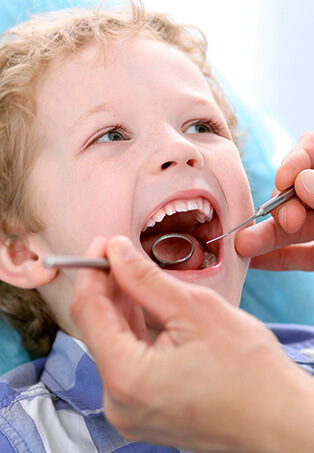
[0,325,314,453]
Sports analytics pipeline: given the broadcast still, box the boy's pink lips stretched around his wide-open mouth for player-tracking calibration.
[139,188,225,272]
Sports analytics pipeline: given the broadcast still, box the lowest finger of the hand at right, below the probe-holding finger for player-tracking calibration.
[250,242,314,271]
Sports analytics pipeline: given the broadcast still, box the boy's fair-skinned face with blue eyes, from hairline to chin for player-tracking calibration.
[32,38,252,322]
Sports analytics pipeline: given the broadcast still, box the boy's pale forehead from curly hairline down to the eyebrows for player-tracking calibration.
[37,37,216,131]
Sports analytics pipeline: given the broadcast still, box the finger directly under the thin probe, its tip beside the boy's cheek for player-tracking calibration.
[235,211,314,257]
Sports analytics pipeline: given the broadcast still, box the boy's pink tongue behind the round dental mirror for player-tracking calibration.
[141,233,204,270]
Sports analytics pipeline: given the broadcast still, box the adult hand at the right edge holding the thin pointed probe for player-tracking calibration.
[236,132,314,271]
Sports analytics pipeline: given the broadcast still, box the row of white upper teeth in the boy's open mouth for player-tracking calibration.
[143,197,213,231]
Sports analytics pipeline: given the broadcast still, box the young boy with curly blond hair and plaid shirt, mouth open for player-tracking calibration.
[0,6,312,452]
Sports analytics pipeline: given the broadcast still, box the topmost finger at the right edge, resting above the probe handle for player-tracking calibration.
[275,132,314,190]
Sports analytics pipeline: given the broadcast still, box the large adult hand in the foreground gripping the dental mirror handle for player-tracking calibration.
[71,237,314,453]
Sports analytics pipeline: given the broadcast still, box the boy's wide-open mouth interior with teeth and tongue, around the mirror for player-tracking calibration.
[140,197,222,270]
